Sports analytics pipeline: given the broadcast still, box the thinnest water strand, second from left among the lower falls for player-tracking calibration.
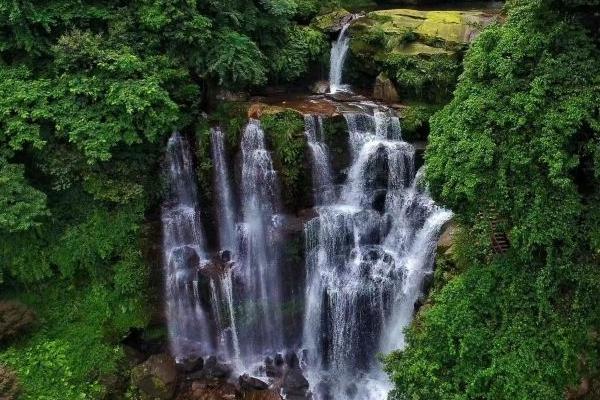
[211,128,236,251]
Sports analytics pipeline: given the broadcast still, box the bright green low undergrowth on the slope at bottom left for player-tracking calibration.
[0,274,148,399]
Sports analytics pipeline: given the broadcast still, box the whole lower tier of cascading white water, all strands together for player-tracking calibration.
[162,102,452,400]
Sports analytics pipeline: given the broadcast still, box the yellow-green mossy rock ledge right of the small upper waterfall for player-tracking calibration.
[346,9,495,103]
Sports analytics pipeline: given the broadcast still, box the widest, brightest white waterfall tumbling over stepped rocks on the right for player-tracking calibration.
[303,108,451,399]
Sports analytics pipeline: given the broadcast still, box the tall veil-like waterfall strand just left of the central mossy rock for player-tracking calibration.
[235,119,283,355]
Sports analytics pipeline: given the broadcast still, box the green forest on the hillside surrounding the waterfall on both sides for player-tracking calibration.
[0,0,600,400]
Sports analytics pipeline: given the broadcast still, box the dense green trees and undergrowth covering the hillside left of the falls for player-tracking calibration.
[0,0,327,399]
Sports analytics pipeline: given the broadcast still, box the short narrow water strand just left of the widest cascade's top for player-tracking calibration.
[304,115,335,205]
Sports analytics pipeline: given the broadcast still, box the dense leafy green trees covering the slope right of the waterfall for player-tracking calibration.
[387,0,600,400]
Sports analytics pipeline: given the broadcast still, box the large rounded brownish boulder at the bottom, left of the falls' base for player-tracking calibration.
[131,354,178,400]
